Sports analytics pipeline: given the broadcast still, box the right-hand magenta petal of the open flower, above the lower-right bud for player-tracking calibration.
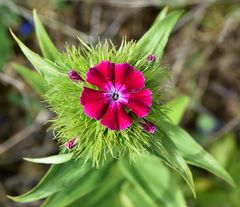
[125,89,152,118]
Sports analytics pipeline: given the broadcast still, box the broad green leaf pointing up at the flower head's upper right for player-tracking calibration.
[135,10,183,64]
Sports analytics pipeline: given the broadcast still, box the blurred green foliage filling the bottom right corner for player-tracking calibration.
[190,134,240,207]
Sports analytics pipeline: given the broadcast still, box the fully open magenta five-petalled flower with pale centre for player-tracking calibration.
[80,61,152,130]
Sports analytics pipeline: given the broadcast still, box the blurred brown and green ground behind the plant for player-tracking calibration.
[0,0,240,207]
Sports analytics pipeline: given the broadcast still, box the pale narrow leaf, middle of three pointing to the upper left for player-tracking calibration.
[10,30,66,80]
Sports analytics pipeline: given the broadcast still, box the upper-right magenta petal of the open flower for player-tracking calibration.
[115,63,145,91]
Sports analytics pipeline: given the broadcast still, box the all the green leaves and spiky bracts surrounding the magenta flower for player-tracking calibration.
[11,9,234,207]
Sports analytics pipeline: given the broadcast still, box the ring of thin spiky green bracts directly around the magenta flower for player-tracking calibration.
[46,39,166,167]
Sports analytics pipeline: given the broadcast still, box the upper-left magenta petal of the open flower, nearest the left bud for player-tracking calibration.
[86,61,115,91]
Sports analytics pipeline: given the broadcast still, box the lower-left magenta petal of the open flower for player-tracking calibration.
[80,87,109,120]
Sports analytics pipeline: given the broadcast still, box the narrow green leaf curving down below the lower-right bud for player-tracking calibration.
[151,130,195,196]
